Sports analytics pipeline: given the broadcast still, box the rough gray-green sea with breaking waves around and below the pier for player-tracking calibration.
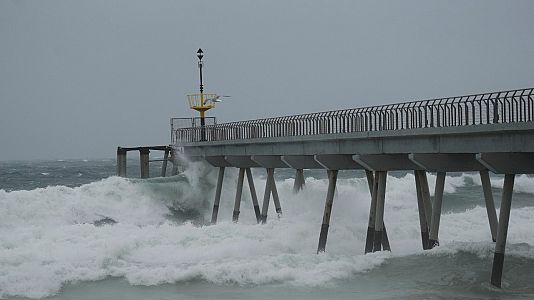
[0,159,534,300]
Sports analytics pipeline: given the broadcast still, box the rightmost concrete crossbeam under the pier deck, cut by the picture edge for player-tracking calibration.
[476,152,534,174]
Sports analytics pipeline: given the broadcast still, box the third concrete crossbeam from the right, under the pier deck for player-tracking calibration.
[352,154,422,171]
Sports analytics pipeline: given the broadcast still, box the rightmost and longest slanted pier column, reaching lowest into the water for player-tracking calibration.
[491,174,515,287]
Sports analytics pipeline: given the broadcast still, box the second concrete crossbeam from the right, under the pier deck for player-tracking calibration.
[408,153,486,172]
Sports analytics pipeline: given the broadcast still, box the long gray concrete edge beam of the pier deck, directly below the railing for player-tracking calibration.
[180,122,534,156]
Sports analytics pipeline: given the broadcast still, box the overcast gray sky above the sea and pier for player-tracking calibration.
[0,0,534,160]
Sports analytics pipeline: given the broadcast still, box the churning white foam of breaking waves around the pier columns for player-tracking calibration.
[0,165,534,298]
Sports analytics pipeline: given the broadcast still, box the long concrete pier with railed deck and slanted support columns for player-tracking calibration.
[171,85,534,287]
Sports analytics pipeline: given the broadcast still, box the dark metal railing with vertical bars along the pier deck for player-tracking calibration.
[172,88,534,143]
